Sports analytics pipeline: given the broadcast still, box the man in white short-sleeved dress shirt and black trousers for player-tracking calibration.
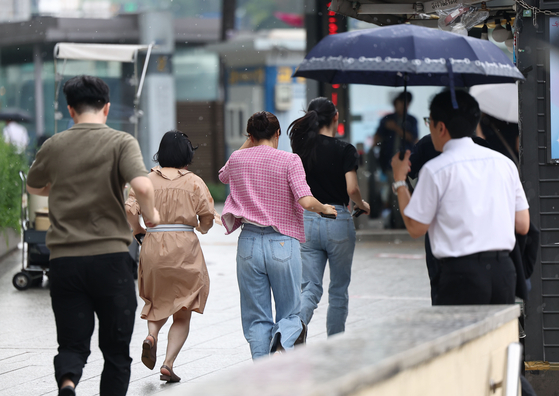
[392,91,530,305]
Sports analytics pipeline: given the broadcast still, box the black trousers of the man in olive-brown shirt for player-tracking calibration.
[49,252,137,396]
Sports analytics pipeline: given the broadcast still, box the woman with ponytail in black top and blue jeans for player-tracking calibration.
[288,98,370,336]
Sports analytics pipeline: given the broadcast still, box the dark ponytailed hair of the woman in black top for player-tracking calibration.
[287,97,338,168]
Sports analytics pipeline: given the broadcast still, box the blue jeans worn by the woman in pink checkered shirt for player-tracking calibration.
[237,224,303,359]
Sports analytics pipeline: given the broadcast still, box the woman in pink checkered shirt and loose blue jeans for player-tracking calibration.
[219,111,336,359]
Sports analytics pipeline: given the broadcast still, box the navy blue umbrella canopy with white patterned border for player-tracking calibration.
[293,25,524,87]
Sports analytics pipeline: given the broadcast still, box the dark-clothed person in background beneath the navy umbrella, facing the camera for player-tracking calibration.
[373,92,418,228]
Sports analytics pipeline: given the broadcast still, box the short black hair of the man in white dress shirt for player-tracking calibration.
[429,90,481,139]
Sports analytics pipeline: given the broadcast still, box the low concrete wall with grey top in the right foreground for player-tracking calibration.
[164,305,520,396]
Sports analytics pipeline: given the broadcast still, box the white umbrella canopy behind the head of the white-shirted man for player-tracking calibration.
[470,84,518,124]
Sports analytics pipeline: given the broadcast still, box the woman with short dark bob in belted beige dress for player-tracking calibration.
[126,131,214,382]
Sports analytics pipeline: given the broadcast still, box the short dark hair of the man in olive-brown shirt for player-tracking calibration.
[63,76,109,114]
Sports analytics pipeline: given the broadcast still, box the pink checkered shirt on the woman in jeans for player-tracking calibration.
[219,145,312,242]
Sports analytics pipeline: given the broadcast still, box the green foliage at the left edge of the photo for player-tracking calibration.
[0,139,28,233]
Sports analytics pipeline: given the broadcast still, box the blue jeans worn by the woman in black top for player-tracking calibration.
[300,205,355,336]
